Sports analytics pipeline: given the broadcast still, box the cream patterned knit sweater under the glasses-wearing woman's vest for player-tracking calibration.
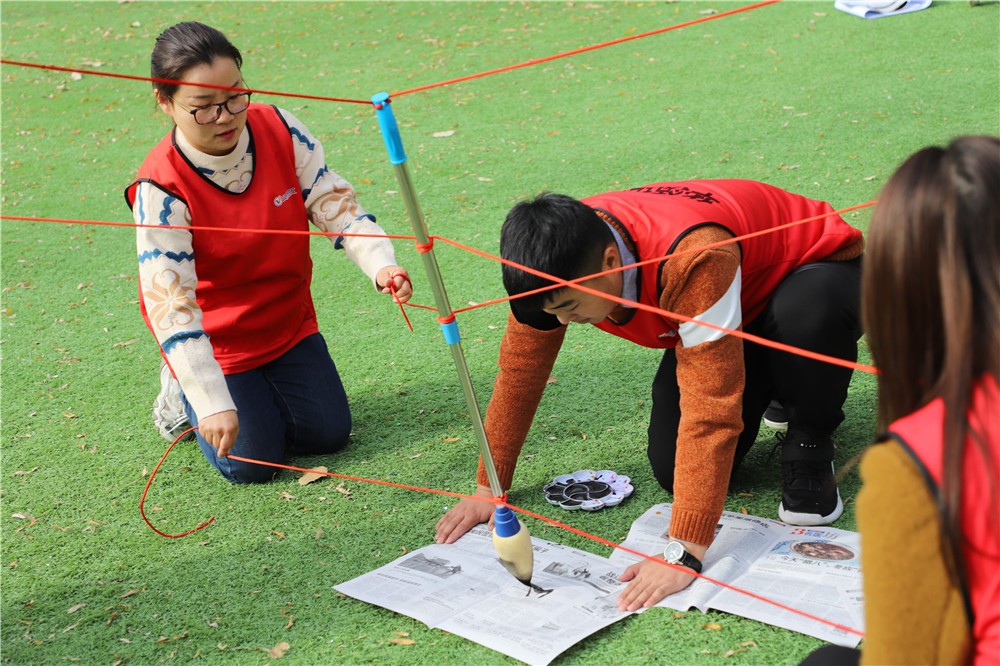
[133,109,396,418]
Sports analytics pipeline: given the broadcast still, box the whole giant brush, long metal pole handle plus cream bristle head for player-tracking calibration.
[372,92,534,587]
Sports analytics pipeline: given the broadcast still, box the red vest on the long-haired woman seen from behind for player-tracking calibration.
[889,376,1000,664]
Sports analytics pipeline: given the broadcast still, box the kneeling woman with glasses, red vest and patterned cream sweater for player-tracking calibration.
[125,22,411,483]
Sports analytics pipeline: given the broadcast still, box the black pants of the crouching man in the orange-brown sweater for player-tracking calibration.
[647,258,861,492]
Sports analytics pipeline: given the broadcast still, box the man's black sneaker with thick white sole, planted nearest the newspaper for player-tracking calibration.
[778,431,844,525]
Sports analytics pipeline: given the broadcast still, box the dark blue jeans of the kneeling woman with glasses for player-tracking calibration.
[184,333,351,483]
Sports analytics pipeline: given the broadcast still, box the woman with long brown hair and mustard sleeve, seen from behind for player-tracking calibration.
[807,136,1000,664]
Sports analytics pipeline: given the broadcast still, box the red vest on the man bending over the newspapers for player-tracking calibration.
[582,180,861,348]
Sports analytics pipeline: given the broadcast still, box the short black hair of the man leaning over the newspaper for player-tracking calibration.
[500,192,614,321]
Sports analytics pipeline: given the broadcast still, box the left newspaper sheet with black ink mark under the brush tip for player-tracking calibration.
[334,525,630,664]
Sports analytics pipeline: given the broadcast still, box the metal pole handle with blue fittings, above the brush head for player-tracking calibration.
[372,92,503,497]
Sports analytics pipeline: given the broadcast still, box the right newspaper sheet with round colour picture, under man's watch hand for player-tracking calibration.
[610,504,864,647]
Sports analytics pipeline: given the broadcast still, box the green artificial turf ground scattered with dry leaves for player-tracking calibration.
[0,1,1000,664]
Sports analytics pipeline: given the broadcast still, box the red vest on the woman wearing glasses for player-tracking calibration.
[125,104,319,374]
